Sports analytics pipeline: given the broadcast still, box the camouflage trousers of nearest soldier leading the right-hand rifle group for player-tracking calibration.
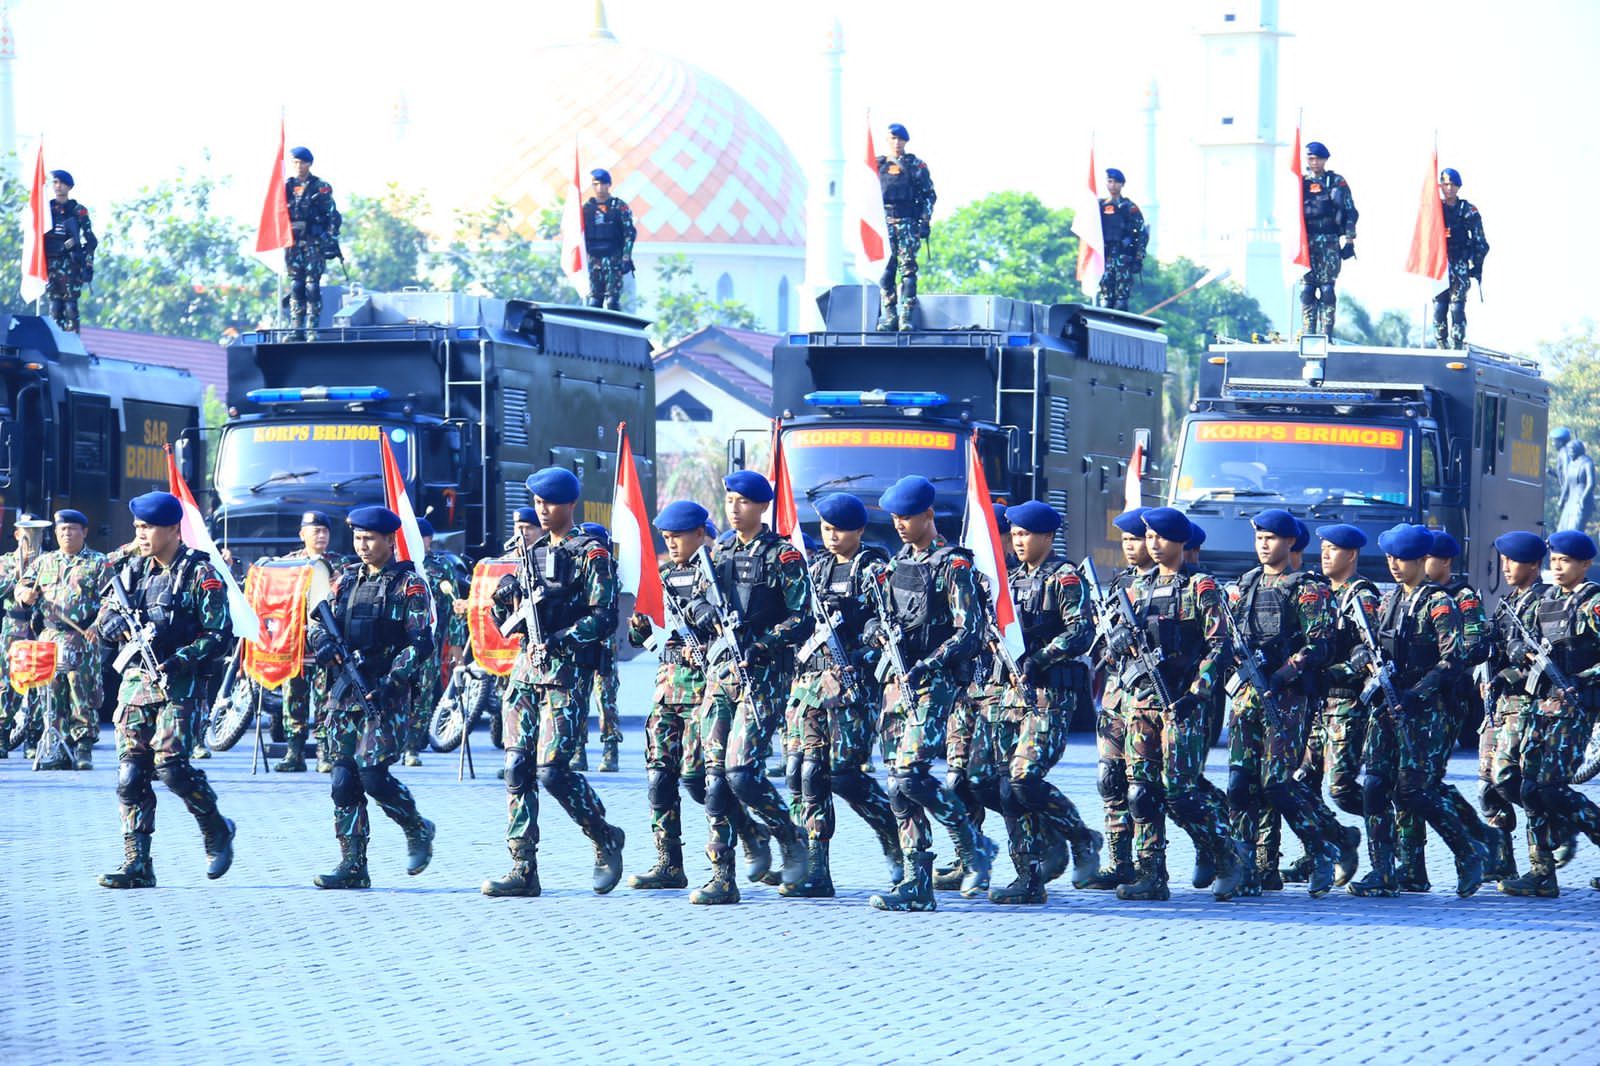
[1125,699,1234,863]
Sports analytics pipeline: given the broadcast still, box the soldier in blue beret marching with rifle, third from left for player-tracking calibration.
[483,466,624,896]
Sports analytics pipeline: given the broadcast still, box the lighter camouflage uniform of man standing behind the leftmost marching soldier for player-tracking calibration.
[27,547,110,758]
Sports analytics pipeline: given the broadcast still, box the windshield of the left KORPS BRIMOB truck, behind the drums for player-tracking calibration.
[216,423,411,496]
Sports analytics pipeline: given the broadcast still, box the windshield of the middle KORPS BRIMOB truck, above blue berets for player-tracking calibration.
[784,426,966,503]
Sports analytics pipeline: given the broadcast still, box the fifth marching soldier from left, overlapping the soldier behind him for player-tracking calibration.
[690,471,813,904]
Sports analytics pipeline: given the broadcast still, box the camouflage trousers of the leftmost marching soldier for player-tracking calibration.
[114,701,218,834]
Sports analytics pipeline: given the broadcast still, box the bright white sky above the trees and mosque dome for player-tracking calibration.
[8,0,1600,352]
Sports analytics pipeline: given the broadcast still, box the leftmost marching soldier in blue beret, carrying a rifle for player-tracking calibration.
[96,493,235,888]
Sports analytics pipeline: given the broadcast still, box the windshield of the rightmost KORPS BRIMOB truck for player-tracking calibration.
[1173,419,1413,507]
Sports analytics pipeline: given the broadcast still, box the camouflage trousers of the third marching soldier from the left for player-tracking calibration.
[501,674,606,858]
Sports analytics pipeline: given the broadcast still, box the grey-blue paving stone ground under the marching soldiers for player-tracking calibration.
[0,661,1600,1064]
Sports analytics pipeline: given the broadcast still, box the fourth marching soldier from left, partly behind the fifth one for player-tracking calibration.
[627,499,712,888]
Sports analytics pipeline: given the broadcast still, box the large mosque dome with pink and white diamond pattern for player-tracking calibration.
[488,17,806,250]
